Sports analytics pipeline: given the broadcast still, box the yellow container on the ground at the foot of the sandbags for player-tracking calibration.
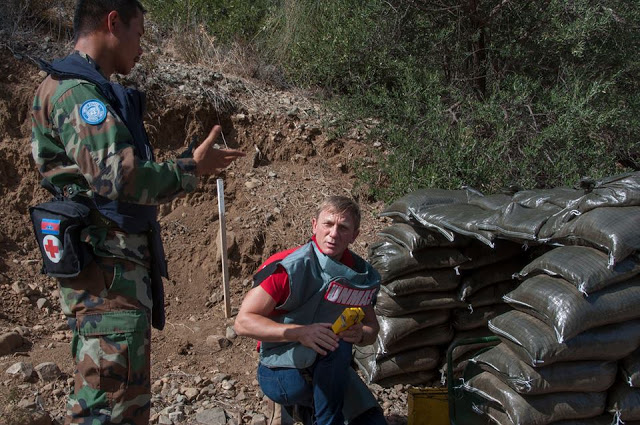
[407,388,450,425]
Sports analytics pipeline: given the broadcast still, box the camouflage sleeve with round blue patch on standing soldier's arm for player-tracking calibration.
[50,82,197,205]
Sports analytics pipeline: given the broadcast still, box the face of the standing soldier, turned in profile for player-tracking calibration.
[114,10,144,74]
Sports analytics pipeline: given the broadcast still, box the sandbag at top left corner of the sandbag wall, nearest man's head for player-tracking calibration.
[380,189,482,223]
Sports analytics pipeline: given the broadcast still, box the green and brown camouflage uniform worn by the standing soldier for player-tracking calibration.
[31,54,197,425]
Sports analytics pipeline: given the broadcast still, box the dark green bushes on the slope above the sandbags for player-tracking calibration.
[144,0,640,200]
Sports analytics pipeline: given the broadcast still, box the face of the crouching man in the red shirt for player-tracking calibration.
[311,210,358,260]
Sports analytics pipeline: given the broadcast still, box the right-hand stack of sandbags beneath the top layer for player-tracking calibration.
[464,242,640,425]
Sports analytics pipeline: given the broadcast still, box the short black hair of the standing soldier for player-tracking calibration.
[73,0,146,40]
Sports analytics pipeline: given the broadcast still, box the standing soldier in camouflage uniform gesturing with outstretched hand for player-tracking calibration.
[31,0,244,425]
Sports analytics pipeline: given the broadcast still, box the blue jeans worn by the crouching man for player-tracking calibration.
[258,341,386,425]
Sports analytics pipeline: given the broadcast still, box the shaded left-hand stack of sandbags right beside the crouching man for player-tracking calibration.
[355,190,523,386]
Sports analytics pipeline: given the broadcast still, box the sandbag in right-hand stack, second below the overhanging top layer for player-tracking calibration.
[504,275,640,342]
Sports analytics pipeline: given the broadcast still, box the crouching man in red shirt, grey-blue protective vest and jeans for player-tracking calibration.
[234,196,386,425]
